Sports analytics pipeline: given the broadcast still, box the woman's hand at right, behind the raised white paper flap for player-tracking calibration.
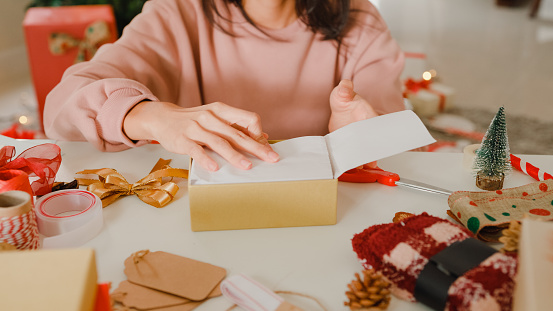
[328,80,378,132]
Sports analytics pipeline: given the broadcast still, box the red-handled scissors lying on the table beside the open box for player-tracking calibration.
[338,167,453,196]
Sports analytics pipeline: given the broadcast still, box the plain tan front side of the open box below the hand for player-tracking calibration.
[188,179,338,231]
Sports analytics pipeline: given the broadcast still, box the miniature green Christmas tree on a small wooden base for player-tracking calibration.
[474,107,511,190]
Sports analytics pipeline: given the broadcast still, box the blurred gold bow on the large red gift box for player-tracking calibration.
[48,21,111,63]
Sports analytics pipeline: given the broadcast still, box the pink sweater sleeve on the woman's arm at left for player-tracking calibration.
[44,1,186,151]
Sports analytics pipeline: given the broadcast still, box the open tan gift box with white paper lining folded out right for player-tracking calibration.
[188,111,434,231]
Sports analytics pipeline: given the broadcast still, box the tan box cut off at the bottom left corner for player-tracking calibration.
[0,249,97,311]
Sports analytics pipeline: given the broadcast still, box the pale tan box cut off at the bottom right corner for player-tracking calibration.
[513,218,553,311]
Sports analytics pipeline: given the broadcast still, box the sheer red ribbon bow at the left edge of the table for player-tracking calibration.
[0,144,61,195]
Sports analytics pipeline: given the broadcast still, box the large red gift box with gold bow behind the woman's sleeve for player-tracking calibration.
[23,5,117,132]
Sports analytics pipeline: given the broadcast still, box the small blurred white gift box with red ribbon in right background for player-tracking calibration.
[403,79,455,117]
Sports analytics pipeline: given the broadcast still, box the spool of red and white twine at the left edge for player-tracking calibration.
[0,190,39,249]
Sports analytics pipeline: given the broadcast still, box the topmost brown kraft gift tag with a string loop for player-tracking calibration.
[125,251,227,301]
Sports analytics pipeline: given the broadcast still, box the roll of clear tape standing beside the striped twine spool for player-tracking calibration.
[35,189,104,248]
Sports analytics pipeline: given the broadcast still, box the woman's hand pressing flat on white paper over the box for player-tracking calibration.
[123,101,279,171]
